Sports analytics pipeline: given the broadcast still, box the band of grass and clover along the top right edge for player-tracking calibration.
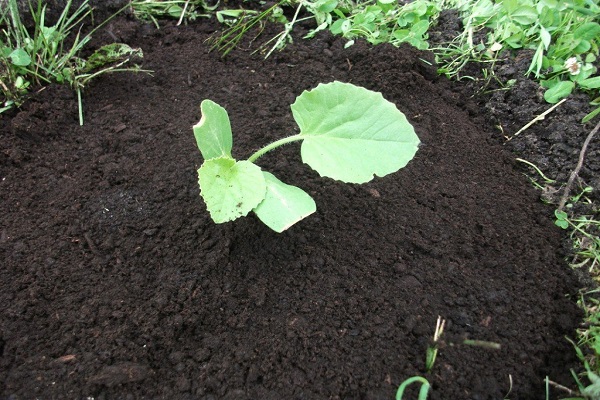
[205,0,600,122]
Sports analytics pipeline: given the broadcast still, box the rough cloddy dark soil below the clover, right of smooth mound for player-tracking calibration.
[430,11,600,206]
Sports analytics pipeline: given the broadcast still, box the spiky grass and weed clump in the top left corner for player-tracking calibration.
[0,0,148,124]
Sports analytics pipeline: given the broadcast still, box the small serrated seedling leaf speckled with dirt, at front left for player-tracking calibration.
[198,157,267,224]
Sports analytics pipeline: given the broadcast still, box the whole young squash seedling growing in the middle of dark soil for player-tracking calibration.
[194,82,419,233]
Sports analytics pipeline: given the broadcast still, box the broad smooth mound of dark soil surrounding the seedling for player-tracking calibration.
[0,11,581,399]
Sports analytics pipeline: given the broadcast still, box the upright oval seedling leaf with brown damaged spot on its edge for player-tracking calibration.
[194,100,233,160]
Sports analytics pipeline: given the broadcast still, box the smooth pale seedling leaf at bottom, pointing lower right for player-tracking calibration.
[254,172,317,233]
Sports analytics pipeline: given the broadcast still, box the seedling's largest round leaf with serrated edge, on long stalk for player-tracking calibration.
[292,82,419,183]
